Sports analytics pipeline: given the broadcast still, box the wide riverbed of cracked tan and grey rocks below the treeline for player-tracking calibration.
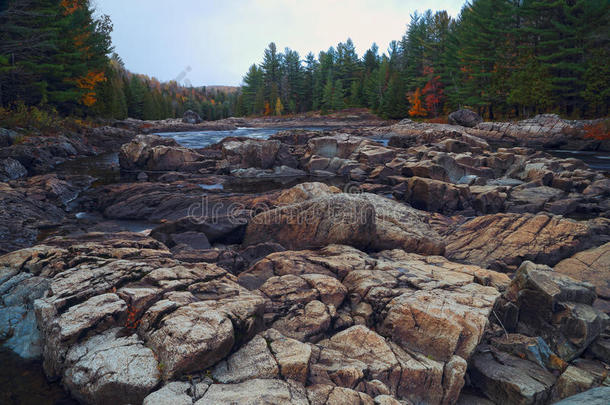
[0,111,610,405]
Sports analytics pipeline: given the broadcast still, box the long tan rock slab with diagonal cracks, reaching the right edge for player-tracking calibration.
[446,214,610,270]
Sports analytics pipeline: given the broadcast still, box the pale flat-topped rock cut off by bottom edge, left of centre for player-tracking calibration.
[195,379,309,405]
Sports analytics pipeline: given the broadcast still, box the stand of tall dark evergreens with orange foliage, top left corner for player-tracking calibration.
[0,0,112,113]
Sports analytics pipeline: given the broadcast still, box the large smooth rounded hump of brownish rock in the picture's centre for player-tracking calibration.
[244,185,443,254]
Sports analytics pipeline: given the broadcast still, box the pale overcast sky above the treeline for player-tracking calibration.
[92,0,465,86]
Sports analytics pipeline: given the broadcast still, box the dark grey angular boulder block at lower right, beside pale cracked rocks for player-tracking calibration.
[506,261,608,361]
